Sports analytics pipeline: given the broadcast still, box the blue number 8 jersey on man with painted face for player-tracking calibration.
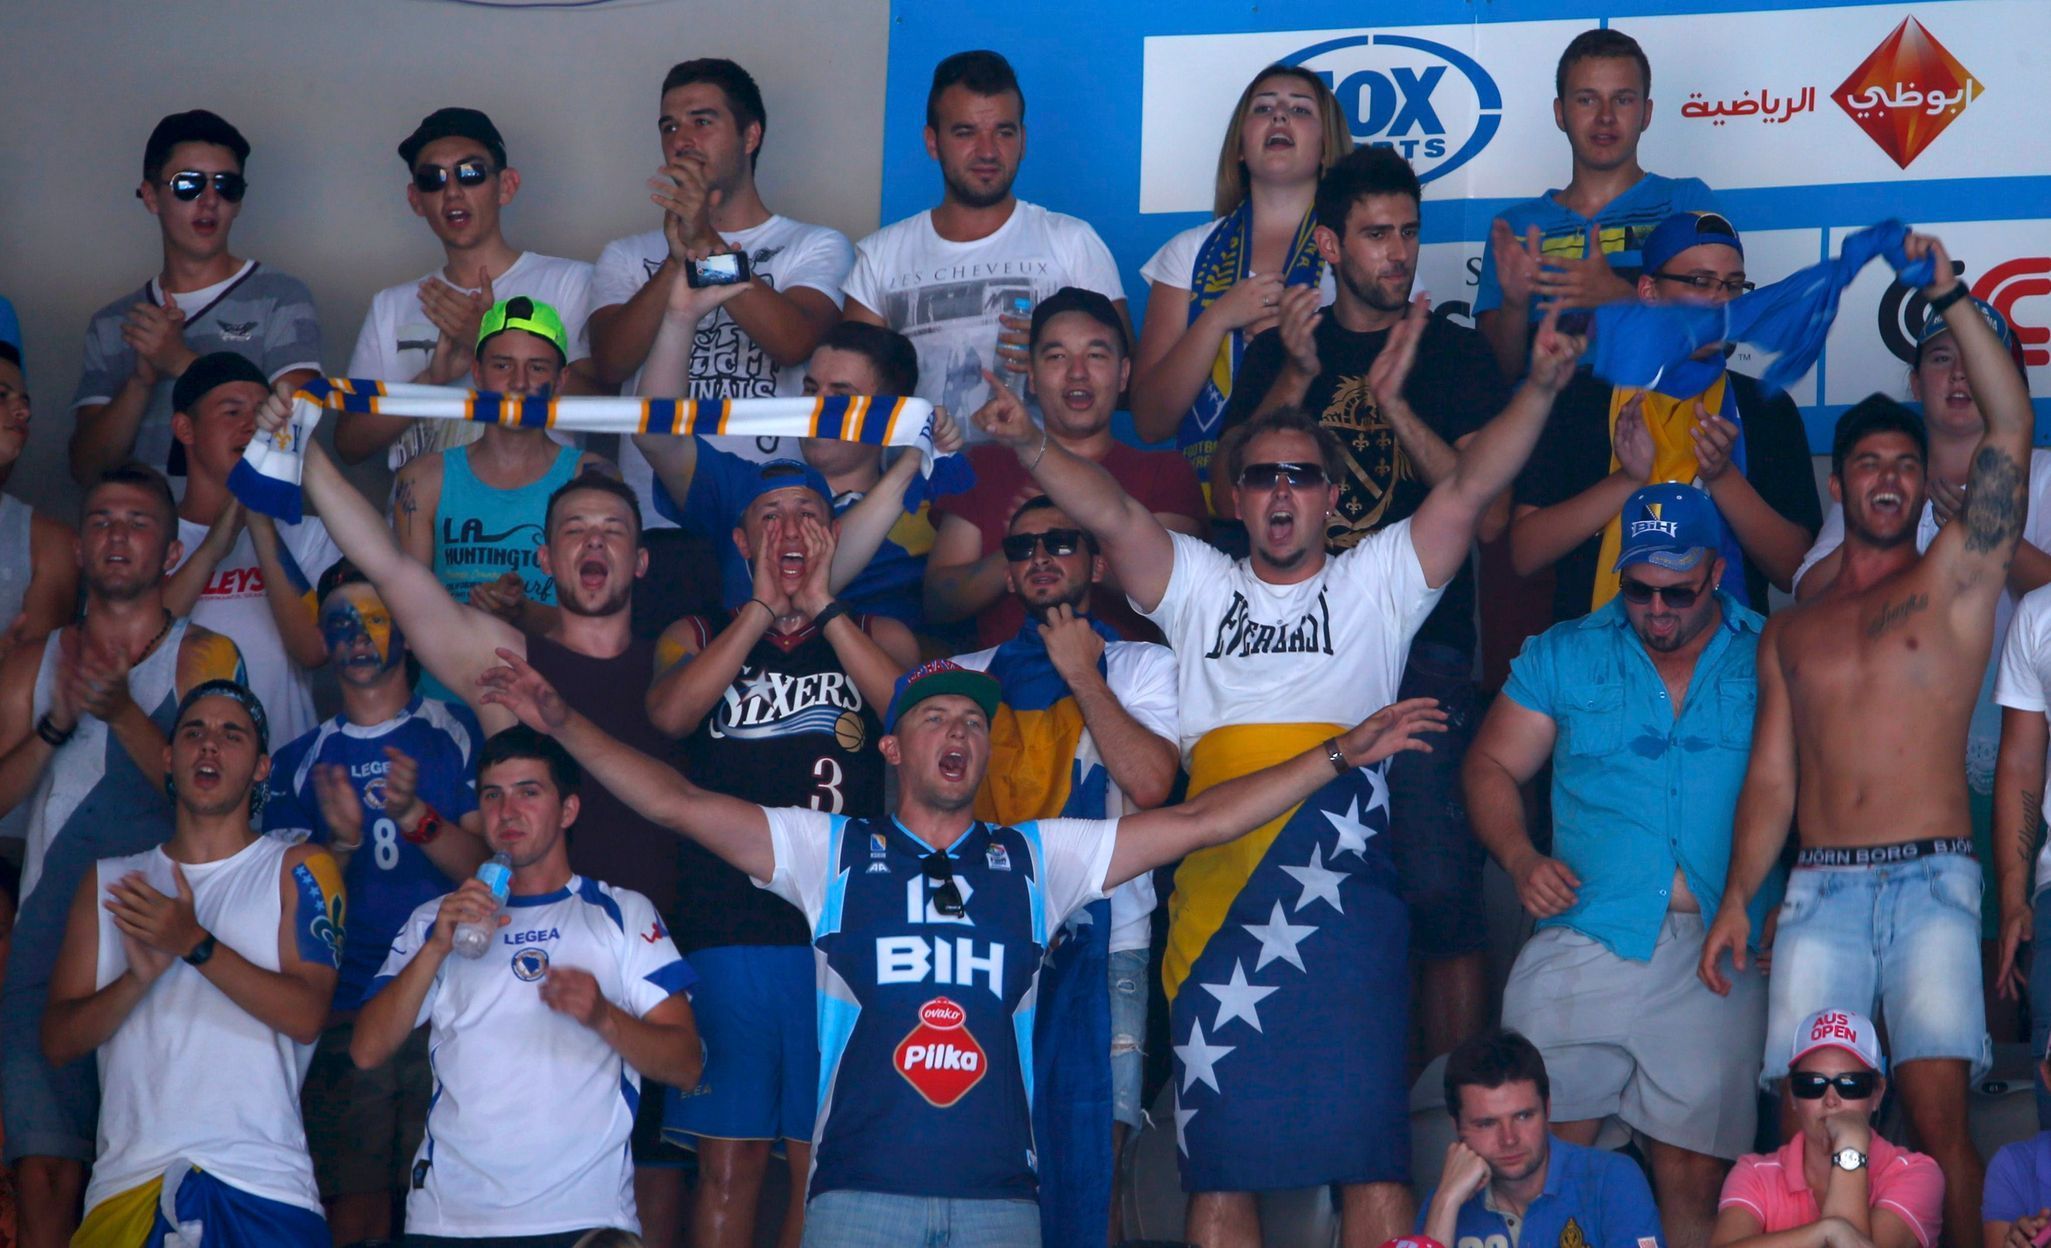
[263,698,484,1010]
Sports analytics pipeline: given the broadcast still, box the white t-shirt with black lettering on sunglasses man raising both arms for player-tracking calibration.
[1132,519,1446,759]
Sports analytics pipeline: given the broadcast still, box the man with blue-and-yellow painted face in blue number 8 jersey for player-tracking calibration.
[263,560,484,1244]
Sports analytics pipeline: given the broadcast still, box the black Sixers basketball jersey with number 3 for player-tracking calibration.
[675,618,884,952]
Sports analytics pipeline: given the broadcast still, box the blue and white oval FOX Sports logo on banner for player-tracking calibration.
[1282,35,1503,183]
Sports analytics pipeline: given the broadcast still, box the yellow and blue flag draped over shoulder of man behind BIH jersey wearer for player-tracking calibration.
[976,620,1118,1248]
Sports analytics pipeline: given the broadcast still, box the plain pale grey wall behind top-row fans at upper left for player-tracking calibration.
[0,0,888,509]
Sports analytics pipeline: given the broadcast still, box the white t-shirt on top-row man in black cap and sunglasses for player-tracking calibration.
[349,250,591,472]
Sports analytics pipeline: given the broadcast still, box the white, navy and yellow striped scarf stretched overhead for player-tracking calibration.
[228,378,943,523]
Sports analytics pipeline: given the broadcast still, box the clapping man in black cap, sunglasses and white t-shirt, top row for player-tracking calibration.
[334,109,591,472]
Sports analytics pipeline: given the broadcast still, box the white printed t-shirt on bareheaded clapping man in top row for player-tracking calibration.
[591,216,855,530]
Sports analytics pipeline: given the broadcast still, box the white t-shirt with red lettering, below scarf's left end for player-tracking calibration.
[178,515,343,749]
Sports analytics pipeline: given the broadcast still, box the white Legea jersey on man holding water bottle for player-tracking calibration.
[371,876,697,1238]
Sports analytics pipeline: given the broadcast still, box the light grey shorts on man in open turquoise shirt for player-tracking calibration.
[1503,913,1766,1158]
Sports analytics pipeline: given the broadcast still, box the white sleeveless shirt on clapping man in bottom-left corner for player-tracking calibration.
[86,835,324,1213]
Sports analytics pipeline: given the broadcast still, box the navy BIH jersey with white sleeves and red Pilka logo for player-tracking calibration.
[763,807,1116,1201]
